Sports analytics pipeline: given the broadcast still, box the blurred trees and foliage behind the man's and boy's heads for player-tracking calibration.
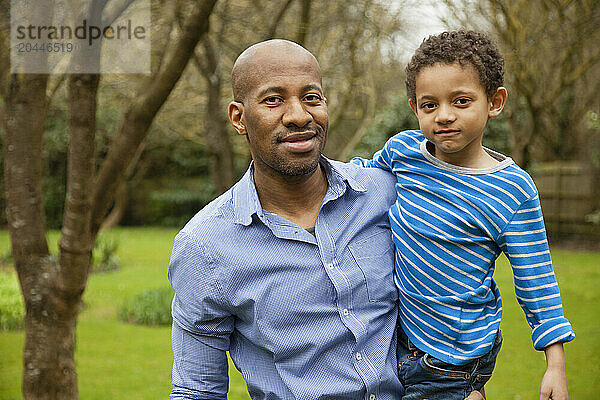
[0,0,600,228]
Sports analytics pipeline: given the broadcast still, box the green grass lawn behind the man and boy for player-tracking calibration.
[0,228,600,400]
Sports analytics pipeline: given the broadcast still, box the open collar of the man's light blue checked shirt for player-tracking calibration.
[232,156,367,226]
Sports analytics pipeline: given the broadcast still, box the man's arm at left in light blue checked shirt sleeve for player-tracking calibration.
[167,233,234,400]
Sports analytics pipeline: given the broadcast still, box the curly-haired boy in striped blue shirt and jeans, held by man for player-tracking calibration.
[355,31,575,400]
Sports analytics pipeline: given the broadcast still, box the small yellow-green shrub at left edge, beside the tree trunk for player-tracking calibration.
[0,272,25,331]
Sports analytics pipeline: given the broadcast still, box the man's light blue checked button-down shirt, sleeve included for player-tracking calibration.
[168,158,403,400]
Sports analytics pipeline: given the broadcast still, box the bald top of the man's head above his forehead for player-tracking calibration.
[231,39,321,102]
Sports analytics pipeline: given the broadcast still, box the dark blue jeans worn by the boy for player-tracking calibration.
[397,325,502,400]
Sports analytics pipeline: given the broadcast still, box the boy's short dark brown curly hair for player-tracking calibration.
[406,30,504,103]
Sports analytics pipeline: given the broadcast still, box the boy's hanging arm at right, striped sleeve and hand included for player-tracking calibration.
[499,193,575,400]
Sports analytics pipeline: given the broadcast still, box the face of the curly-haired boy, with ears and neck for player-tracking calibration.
[410,63,506,166]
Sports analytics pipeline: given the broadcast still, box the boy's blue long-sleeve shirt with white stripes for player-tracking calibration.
[353,131,575,365]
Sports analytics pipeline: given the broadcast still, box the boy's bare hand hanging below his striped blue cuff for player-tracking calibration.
[540,343,569,400]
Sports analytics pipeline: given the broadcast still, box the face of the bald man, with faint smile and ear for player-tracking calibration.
[234,52,328,176]
